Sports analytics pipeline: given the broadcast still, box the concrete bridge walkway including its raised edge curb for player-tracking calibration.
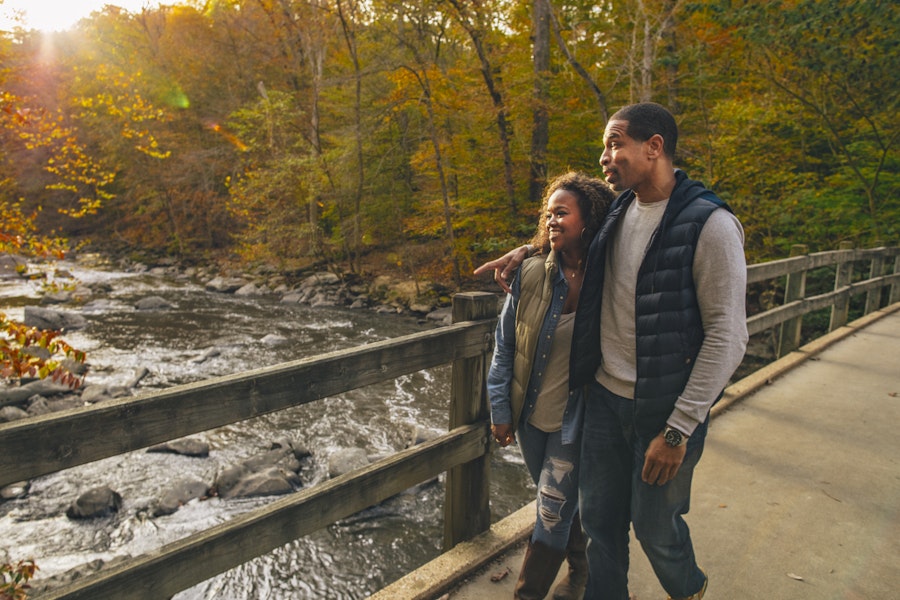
[375,304,900,600]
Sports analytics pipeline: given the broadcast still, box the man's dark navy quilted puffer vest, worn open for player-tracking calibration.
[569,171,731,437]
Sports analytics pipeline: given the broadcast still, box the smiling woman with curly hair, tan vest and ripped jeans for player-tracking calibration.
[487,172,615,600]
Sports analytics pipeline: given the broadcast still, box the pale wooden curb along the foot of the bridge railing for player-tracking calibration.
[369,302,900,600]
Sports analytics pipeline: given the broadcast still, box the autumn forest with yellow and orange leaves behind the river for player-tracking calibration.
[0,0,900,288]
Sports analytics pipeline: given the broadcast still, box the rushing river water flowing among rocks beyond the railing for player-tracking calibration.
[0,256,533,600]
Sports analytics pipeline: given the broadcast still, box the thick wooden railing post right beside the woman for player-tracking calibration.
[444,292,497,552]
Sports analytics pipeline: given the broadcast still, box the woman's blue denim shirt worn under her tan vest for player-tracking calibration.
[487,253,584,444]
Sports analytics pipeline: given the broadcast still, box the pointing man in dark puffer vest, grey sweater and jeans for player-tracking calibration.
[476,102,748,600]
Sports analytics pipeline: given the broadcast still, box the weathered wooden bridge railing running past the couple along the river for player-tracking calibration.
[0,247,900,600]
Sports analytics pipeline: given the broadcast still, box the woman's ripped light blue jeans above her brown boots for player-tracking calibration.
[516,419,581,551]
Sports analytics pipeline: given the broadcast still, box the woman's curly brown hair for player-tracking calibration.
[531,171,616,254]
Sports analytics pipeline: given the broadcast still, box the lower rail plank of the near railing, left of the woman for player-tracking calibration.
[42,422,490,600]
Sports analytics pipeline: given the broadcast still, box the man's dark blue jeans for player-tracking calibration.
[579,382,708,600]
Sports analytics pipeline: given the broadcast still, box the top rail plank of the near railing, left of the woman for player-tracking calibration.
[0,321,494,486]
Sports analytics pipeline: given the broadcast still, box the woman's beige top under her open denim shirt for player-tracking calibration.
[528,312,575,433]
